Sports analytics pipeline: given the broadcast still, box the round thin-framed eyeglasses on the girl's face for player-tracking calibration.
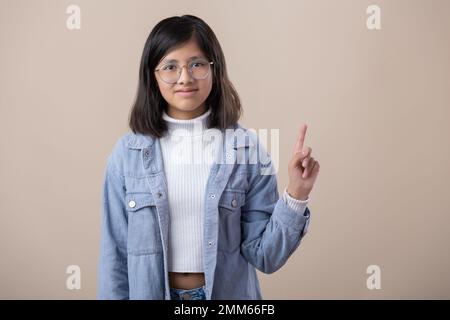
[155,58,214,84]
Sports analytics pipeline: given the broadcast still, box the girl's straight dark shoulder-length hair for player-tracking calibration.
[129,15,242,138]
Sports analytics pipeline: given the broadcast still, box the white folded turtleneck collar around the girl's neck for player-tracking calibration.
[162,108,211,136]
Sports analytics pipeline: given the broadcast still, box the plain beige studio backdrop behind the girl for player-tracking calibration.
[0,0,450,299]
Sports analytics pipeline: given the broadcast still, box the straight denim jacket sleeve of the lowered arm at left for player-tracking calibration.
[97,156,129,300]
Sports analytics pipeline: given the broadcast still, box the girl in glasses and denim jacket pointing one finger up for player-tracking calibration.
[98,15,319,300]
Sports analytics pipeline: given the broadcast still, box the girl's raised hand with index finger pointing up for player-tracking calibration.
[287,124,320,200]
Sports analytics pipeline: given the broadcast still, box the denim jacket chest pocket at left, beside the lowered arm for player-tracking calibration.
[125,192,162,255]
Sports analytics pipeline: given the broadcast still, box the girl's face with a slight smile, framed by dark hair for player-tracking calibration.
[155,39,213,119]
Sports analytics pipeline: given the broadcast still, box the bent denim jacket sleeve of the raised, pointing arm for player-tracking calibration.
[241,144,310,274]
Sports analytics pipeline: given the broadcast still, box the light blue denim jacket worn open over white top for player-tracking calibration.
[97,124,310,300]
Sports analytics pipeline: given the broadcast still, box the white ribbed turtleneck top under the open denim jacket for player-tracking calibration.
[160,109,220,272]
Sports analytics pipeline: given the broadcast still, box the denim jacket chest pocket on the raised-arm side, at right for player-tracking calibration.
[217,189,245,252]
